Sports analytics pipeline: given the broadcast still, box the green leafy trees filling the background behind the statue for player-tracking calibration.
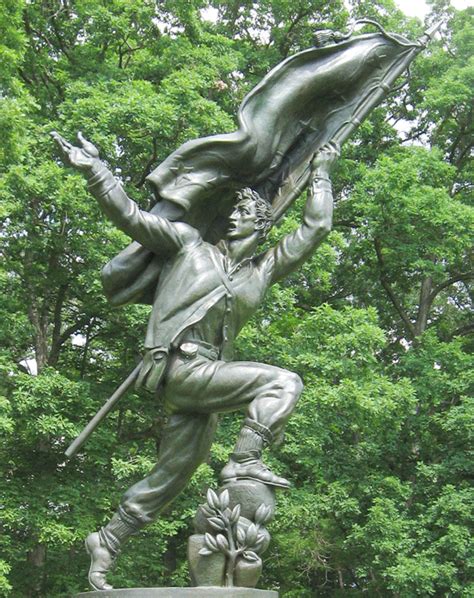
[0,0,474,598]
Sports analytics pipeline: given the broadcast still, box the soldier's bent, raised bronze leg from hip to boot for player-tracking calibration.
[165,358,303,487]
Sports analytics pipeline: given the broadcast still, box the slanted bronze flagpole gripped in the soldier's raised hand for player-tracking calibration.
[273,21,442,221]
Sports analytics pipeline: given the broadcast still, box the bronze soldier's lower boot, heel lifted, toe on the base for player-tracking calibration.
[85,507,143,591]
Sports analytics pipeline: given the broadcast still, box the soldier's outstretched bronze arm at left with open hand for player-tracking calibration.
[52,133,199,254]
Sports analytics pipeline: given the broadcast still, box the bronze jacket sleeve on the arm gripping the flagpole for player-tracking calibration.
[260,176,333,284]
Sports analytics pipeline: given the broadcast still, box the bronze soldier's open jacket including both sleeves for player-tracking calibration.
[89,168,332,392]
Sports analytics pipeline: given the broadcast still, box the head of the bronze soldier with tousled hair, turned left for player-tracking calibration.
[227,187,273,241]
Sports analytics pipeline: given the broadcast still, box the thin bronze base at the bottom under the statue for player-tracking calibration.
[75,586,278,598]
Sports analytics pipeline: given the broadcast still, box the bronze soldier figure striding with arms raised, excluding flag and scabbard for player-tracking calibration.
[53,133,339,590]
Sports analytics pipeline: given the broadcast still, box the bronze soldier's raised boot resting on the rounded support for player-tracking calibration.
[220,418,290,488]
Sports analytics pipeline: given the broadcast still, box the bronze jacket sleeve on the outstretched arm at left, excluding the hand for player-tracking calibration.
[87,166,199,254]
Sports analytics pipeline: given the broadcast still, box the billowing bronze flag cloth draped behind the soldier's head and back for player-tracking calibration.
[102,33,413,305]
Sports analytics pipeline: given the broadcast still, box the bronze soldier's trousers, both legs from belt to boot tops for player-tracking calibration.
[121,355,303,523]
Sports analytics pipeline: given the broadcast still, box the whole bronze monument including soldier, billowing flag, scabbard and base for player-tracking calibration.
[53,21,436,596]
